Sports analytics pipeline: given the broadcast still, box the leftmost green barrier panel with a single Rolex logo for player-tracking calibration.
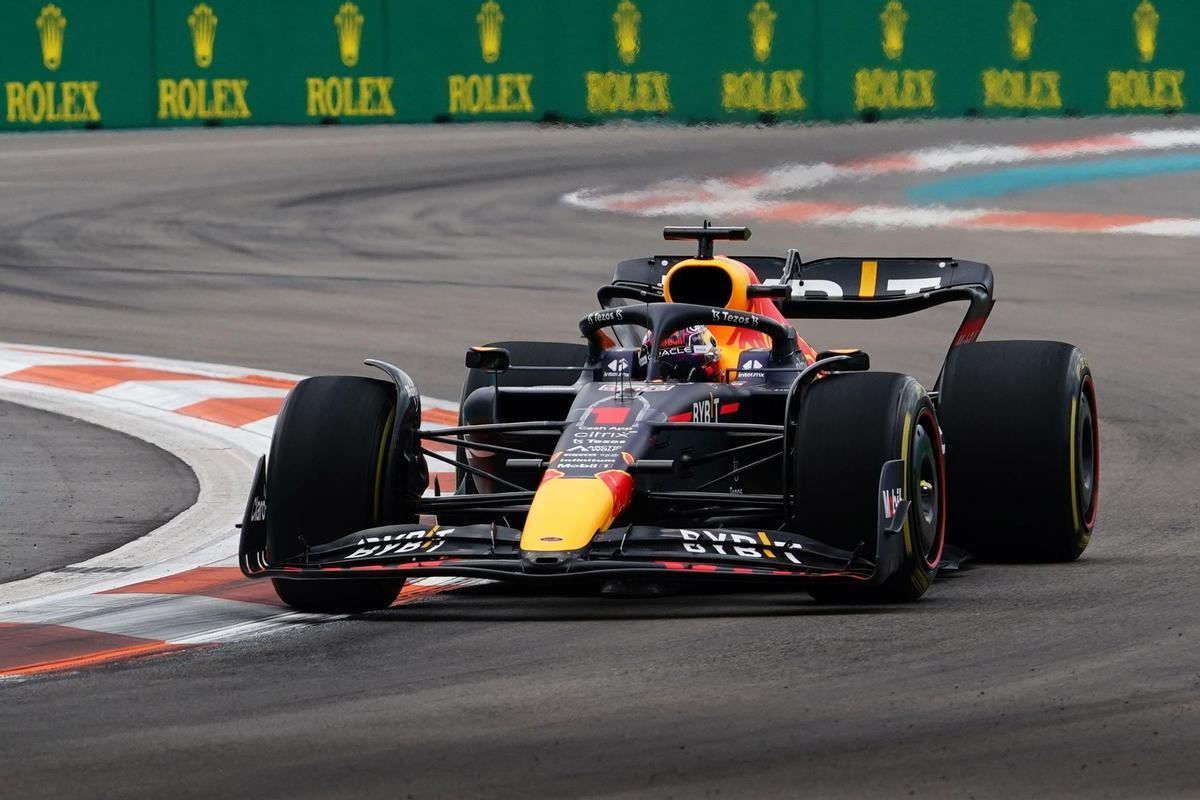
[0,0,151,131]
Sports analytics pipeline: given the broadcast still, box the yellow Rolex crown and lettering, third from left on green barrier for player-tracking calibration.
[305,2,396,119]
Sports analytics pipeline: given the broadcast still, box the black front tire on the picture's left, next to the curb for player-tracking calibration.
[266,375,409,614]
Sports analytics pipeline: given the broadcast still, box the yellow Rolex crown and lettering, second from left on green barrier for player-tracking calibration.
[158,2,251,121]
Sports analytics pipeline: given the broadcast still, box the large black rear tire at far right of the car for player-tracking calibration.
[938,342,1100,561]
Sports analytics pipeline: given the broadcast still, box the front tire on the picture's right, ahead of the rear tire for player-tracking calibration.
[791,372,946,603]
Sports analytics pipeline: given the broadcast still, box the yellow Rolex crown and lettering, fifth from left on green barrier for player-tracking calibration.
[583,0,671,114]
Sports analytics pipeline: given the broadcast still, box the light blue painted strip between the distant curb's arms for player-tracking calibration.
[907,154,1200,203]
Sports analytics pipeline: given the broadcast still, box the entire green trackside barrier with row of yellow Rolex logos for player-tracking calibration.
[0,0,1200,130]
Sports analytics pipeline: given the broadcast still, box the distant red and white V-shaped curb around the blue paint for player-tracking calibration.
[563,128,1200,236]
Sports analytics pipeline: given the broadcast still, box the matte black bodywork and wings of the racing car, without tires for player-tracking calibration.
[240,247,992,585]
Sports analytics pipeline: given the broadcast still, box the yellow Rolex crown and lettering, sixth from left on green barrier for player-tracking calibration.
[721,0,808,114]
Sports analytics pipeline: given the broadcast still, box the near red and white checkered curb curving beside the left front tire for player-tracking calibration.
[0,343,468,679]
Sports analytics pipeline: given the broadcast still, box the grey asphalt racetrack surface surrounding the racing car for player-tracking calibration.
[0,118,1200,796]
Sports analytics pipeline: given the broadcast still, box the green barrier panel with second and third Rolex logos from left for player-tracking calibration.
[154,0,398,125]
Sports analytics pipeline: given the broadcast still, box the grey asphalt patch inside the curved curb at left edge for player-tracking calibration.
[0,403,199,583]
